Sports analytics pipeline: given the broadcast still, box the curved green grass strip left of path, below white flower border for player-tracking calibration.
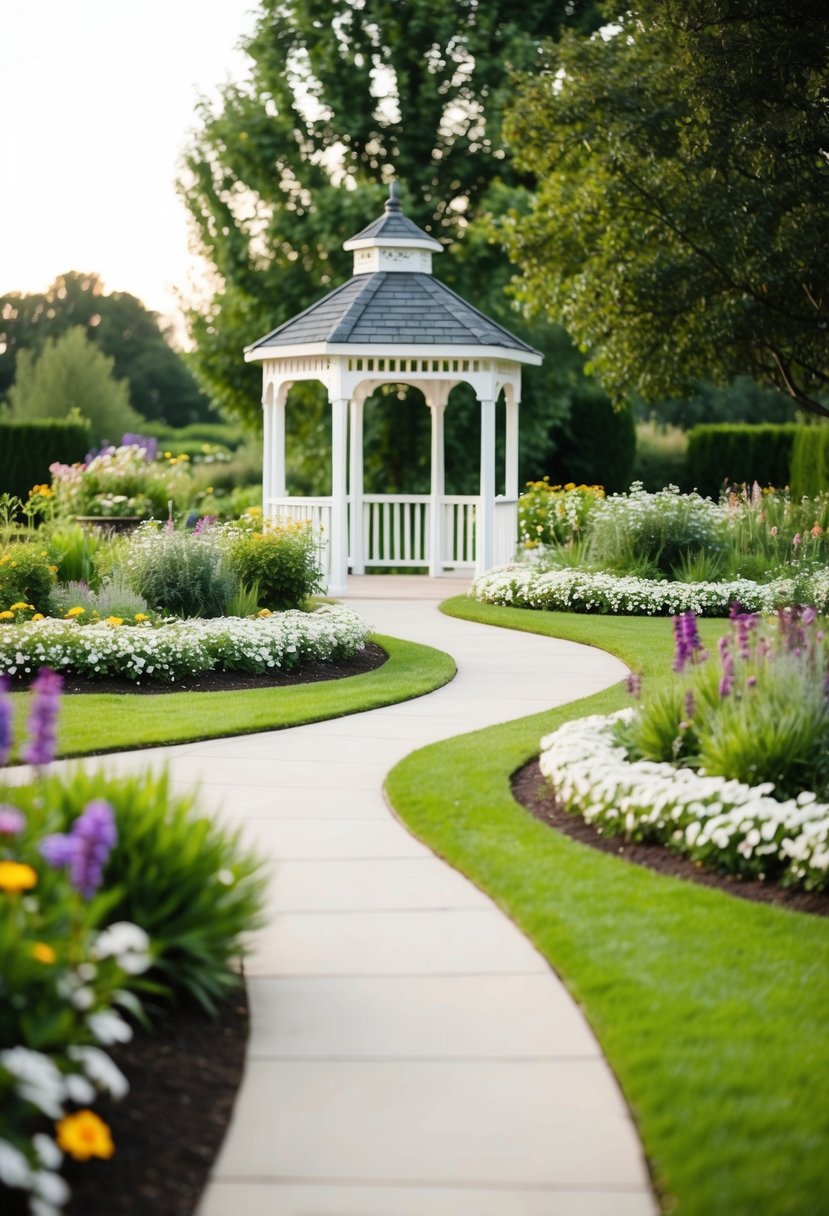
[13,635,456,756]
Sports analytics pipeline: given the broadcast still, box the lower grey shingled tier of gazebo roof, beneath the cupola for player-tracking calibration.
[248,273,536,354]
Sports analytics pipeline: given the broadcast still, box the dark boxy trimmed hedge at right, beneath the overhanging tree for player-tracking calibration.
[686,422,797,500]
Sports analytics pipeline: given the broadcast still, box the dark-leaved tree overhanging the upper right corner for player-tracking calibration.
[504,0,829,415]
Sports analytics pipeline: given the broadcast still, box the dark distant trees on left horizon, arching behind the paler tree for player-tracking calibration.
[0,271,210,426]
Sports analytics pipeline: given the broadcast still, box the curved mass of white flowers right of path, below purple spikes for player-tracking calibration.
[540,709,829,890]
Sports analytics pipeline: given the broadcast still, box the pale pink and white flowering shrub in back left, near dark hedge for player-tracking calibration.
[50,447,192,518]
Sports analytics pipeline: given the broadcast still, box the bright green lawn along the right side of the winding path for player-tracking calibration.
[388,598,829,1216]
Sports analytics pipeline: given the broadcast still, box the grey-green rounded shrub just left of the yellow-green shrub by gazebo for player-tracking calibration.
[117,523,237,617]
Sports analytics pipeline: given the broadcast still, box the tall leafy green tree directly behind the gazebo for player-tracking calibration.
[181,0,598,489]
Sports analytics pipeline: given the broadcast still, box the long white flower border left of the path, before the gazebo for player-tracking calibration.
[0,604,370,683]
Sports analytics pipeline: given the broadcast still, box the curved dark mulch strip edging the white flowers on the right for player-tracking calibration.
[512,760,829,916]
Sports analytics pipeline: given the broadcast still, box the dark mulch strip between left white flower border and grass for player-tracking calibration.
[15,642,389,696]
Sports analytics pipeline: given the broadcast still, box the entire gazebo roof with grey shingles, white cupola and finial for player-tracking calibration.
[246,182,541,364]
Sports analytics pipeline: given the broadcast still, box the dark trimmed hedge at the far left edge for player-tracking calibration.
[0,418,92,500]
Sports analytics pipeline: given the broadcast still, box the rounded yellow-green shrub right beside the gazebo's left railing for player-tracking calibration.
[225,522,322,612]
